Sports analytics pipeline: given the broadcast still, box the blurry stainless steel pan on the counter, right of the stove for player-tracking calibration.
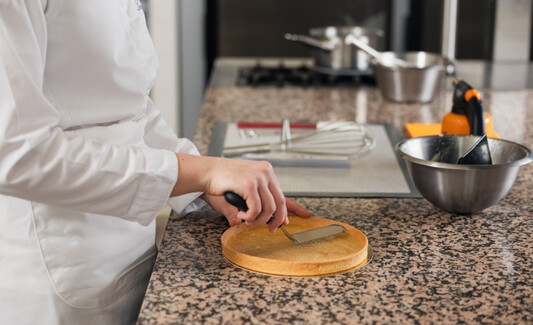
[372,52,450,103]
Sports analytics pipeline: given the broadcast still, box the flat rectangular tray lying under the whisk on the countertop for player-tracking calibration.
[208,122,421,198]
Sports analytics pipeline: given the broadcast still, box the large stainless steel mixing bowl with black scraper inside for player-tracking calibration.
[395,135,533,214]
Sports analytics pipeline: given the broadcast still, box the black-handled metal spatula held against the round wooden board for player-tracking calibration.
[224,192,346,244]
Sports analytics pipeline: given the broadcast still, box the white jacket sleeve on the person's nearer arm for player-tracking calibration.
[0,0,178,224]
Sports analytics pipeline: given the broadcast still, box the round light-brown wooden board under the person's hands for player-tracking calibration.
[221,217,368,276]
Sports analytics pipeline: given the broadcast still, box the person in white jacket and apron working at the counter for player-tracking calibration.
[0,0,307,324]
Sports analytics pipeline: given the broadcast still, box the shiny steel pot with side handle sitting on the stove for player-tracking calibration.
[285,26,383,75]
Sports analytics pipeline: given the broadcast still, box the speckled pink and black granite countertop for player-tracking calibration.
[139,67,533,324]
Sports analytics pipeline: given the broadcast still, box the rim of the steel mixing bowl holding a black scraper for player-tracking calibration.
[394,135,533,170]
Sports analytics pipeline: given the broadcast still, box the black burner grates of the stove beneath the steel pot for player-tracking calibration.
[237,64,375,88]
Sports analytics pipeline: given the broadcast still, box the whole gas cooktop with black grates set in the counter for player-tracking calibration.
[210,58,376,88]
